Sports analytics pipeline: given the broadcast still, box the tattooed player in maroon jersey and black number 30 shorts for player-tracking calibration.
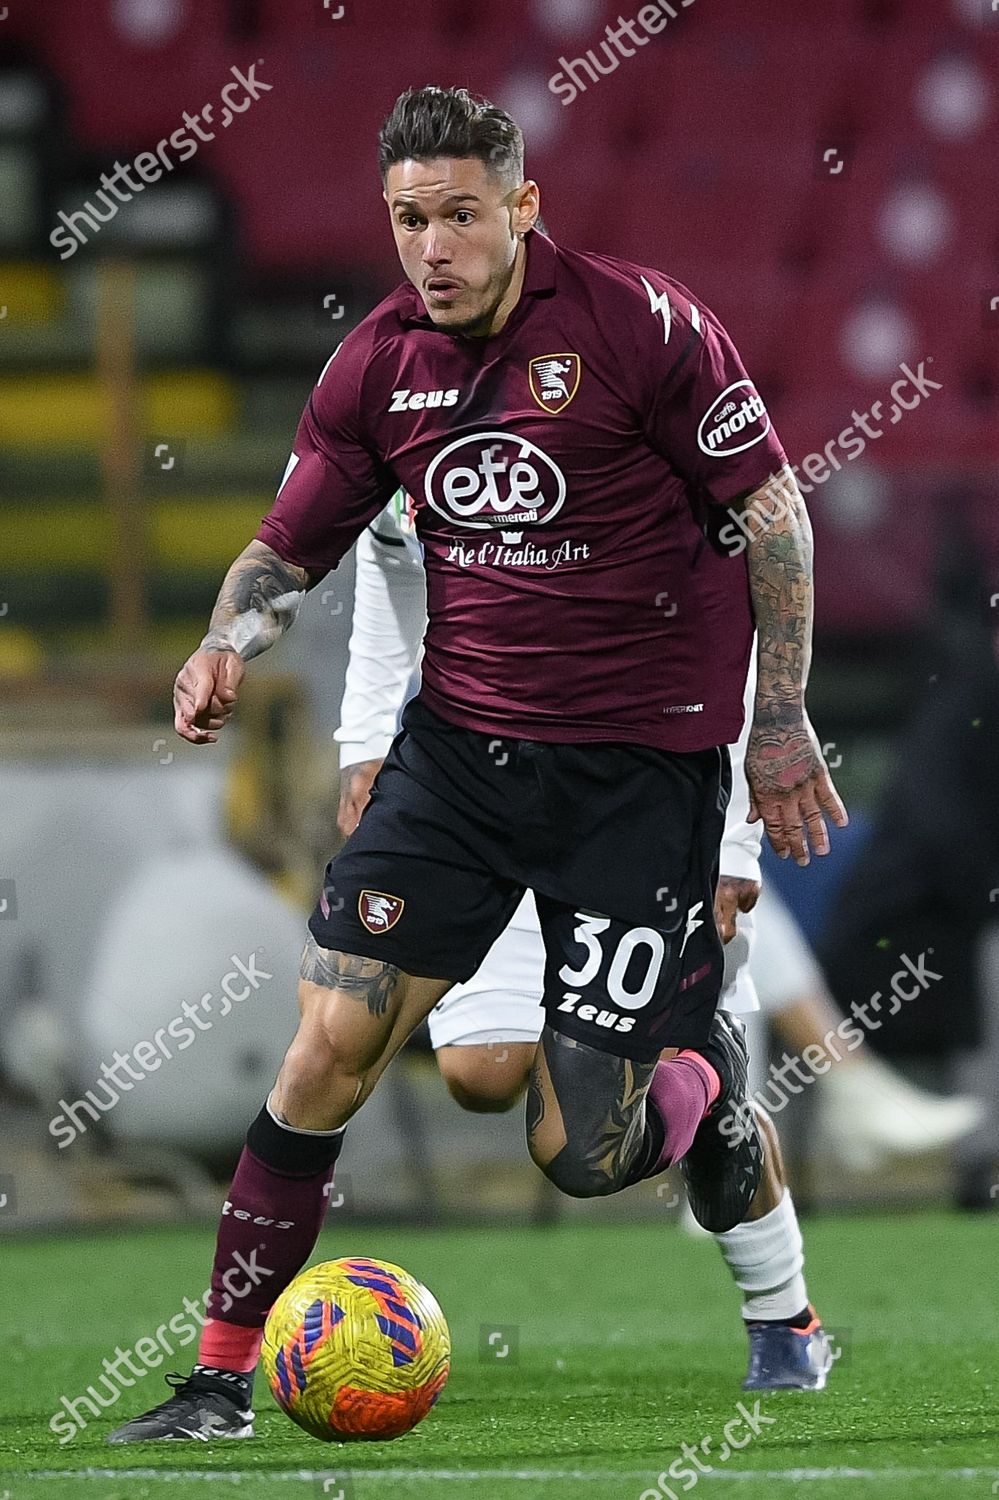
[113,87,846,1442]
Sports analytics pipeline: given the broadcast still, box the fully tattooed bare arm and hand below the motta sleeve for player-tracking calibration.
[744,470,846,864]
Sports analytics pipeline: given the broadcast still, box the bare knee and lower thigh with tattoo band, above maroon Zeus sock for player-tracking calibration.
[270,935,452,1130]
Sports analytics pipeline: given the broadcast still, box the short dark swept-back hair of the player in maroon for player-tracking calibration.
[378,84,524,186]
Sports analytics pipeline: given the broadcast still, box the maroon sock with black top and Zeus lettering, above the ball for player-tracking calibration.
[207,1106,344,1332]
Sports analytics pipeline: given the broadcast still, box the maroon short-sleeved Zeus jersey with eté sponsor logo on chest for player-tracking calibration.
[258,230,786,750]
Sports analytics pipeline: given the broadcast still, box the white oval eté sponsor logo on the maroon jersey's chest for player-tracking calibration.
[423,432,566,531]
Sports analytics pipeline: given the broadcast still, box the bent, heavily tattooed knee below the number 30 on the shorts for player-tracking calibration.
[527,1026,662,1199]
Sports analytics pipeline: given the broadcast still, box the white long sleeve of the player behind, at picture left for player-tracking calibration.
[333,513,426,767]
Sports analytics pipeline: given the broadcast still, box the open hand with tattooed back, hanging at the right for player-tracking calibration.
[746,716,849,866]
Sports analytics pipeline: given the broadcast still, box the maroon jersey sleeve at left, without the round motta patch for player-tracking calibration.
[257,335,399,575]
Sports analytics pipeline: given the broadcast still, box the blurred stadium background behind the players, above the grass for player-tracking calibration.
[0,0,999,1230]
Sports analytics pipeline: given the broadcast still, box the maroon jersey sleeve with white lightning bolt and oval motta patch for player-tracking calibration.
[642,276,788,506]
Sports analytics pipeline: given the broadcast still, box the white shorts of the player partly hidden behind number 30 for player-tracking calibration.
[428,891,759,1049]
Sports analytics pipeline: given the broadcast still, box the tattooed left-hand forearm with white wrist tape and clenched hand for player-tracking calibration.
[174,542,320,746]
